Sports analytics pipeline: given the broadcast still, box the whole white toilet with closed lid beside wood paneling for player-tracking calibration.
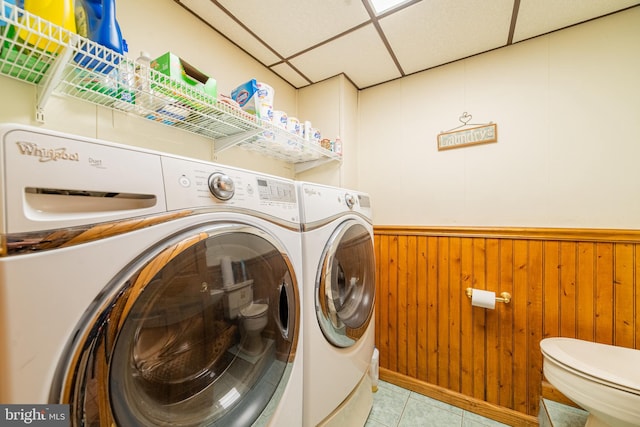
[540,338,640,427]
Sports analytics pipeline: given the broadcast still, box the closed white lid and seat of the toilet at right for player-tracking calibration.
[540,337,640,394]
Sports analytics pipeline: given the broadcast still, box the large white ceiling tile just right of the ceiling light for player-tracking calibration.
[380,0,513,74]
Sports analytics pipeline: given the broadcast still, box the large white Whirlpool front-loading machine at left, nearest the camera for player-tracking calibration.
[0,125,303,427]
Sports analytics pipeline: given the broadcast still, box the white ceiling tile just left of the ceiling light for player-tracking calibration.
[219,0,369,58]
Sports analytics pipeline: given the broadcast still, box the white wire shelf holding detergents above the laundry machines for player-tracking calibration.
[0,0,341,170]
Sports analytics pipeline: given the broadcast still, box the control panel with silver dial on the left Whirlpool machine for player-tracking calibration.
[162,156,300,223]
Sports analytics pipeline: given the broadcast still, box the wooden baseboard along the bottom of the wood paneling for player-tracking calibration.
[380,368,538,427]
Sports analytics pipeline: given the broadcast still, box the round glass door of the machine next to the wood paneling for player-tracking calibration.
[315,220,375,347]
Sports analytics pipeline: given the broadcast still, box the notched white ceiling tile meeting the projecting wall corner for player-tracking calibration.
[289,24,400,89]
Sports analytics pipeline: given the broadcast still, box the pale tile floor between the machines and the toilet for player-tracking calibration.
[365,381,586,427]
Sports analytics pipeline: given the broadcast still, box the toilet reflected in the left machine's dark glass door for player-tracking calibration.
[223,280,269,356]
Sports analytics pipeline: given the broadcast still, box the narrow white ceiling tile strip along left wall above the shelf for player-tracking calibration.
[180,0,280,65]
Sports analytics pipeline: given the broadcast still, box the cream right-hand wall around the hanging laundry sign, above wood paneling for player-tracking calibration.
[358,8,640,229]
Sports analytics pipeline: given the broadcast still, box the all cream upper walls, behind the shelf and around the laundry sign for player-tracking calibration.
[0,0,640,228]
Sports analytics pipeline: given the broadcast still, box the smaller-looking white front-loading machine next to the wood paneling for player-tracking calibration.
[297,182,375,426]
